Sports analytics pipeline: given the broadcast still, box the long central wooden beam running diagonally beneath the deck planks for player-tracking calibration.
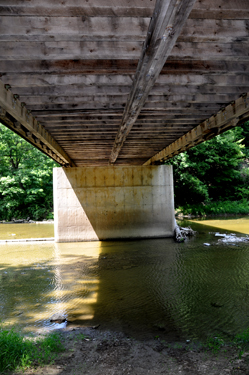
[109,0,196,164]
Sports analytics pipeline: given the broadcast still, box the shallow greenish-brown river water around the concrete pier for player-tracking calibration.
[0,217,249,339]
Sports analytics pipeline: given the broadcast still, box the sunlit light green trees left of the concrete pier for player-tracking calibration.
[0,124,56,220]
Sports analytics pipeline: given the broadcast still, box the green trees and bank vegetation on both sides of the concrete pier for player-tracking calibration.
[0,122,249,221]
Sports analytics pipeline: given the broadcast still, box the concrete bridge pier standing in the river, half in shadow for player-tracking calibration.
[54,165,175,242]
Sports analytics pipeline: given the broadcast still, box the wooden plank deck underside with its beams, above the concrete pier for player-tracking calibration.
[0,0,249,166]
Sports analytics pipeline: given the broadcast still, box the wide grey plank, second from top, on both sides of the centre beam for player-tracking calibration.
[0,16,249,43]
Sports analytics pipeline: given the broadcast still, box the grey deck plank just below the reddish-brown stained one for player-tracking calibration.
[2,70,249,88]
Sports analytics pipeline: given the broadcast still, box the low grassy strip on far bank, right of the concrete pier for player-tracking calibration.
[177,199,249,216]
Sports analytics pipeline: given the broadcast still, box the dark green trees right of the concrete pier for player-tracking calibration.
[167,122,249,210]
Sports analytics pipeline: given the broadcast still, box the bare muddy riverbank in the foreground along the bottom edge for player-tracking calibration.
[10,327,249,375]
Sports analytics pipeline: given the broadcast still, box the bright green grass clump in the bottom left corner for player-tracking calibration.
[0,327,64,374]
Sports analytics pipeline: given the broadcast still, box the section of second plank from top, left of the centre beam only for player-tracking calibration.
[0,16,150,42]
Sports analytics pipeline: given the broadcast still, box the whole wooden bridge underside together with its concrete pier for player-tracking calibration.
[0,0,249,242]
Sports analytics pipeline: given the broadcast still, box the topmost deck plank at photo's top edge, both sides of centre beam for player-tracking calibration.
[0,0,248,18]
